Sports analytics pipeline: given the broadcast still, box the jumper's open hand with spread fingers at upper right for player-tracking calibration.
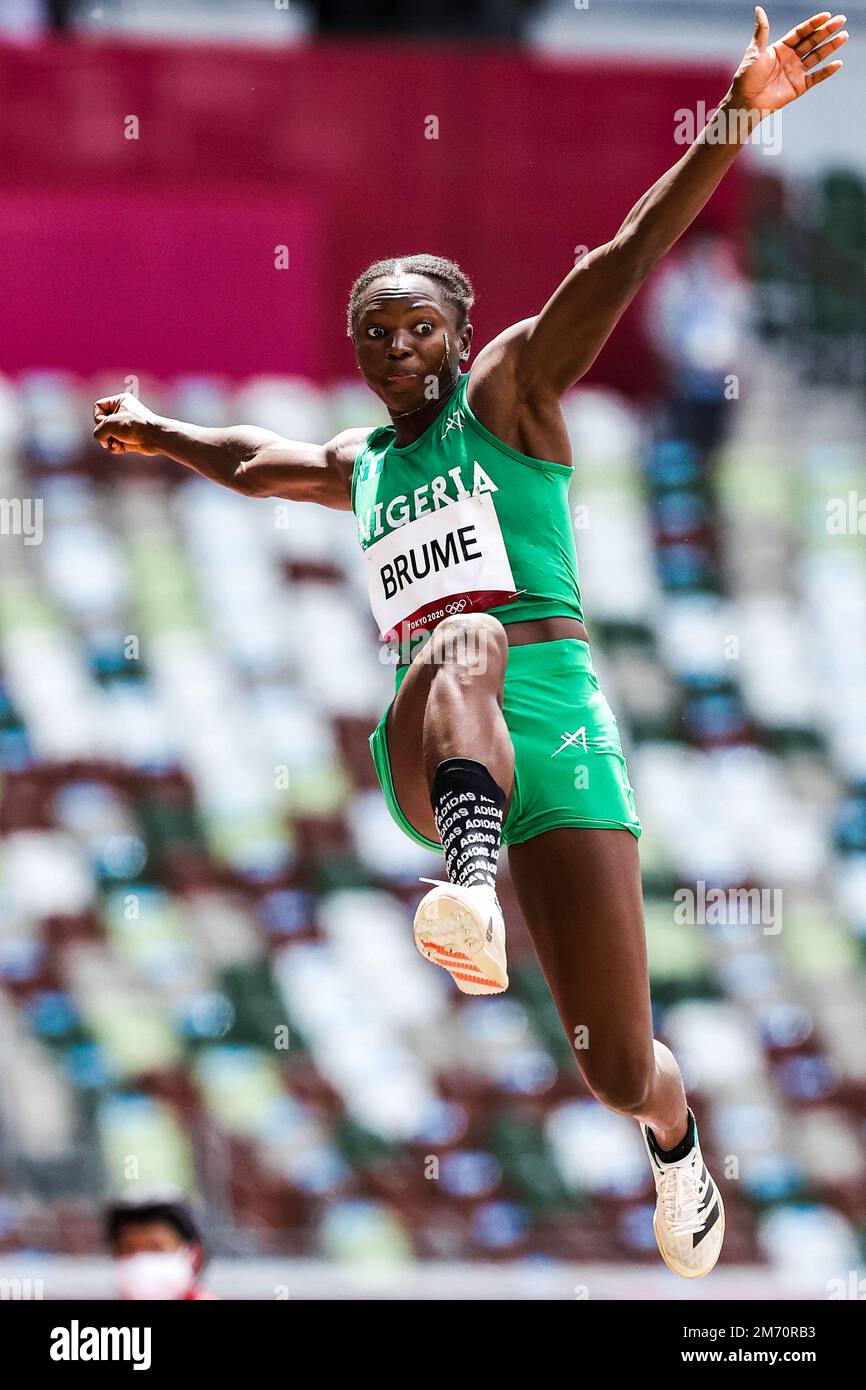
[731,6,848,115]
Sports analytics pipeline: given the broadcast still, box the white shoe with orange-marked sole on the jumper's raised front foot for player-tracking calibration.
[413,878,509,994]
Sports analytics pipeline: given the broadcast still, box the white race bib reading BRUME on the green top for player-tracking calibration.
[364,492,514,641]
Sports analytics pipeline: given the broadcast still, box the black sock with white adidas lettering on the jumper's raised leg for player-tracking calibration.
[430,758,507,888]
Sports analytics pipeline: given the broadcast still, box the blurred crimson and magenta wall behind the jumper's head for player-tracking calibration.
[0,40,741,391]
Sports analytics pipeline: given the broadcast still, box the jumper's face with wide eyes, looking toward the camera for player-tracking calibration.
[354,275,473,414]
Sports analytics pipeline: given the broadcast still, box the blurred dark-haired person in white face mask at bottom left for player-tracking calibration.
[106,1200,215,1301]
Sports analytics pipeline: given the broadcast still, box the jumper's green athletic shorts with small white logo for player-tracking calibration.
[370,638,641,852]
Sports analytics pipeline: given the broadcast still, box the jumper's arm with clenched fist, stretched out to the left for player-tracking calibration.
[93,392,368,512]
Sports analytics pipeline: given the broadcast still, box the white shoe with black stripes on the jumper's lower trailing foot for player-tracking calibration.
[641,1115,724,1279]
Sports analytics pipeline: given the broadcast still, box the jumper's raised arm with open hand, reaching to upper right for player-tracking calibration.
[514,6,848,400]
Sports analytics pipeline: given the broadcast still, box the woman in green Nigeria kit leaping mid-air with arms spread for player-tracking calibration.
[95,7,848,1279]
